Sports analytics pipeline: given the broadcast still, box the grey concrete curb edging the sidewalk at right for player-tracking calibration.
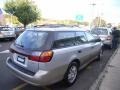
[89,45,120,90]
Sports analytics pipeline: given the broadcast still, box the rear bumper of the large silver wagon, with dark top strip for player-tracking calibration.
[6,57,64,86]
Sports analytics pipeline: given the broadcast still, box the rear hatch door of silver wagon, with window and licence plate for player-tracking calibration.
[11,31,48,72]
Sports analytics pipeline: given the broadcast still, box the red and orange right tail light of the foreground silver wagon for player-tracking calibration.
[28,51,53,62]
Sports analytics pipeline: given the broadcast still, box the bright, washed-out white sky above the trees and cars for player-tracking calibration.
[0,0,120,23]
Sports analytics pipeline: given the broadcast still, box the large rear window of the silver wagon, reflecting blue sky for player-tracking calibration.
[15,31,48,50]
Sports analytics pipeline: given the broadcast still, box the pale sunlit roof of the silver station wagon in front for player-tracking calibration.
[26,27,87,31]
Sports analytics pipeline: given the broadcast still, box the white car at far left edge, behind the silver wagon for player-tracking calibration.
[0,27,16,39]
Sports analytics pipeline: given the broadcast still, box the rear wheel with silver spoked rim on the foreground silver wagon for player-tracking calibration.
[63,62,78,87]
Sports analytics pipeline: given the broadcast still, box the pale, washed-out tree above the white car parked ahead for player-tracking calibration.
[92,17,106,27]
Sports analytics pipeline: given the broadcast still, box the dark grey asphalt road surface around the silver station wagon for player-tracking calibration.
[0,41,114,90]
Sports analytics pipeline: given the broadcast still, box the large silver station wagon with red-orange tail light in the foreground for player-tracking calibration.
[6,27,102,86]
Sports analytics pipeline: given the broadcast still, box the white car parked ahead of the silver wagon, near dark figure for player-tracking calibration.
[91,27,112,48]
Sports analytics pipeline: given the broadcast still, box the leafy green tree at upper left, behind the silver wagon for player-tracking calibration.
[5,0,40,27]
